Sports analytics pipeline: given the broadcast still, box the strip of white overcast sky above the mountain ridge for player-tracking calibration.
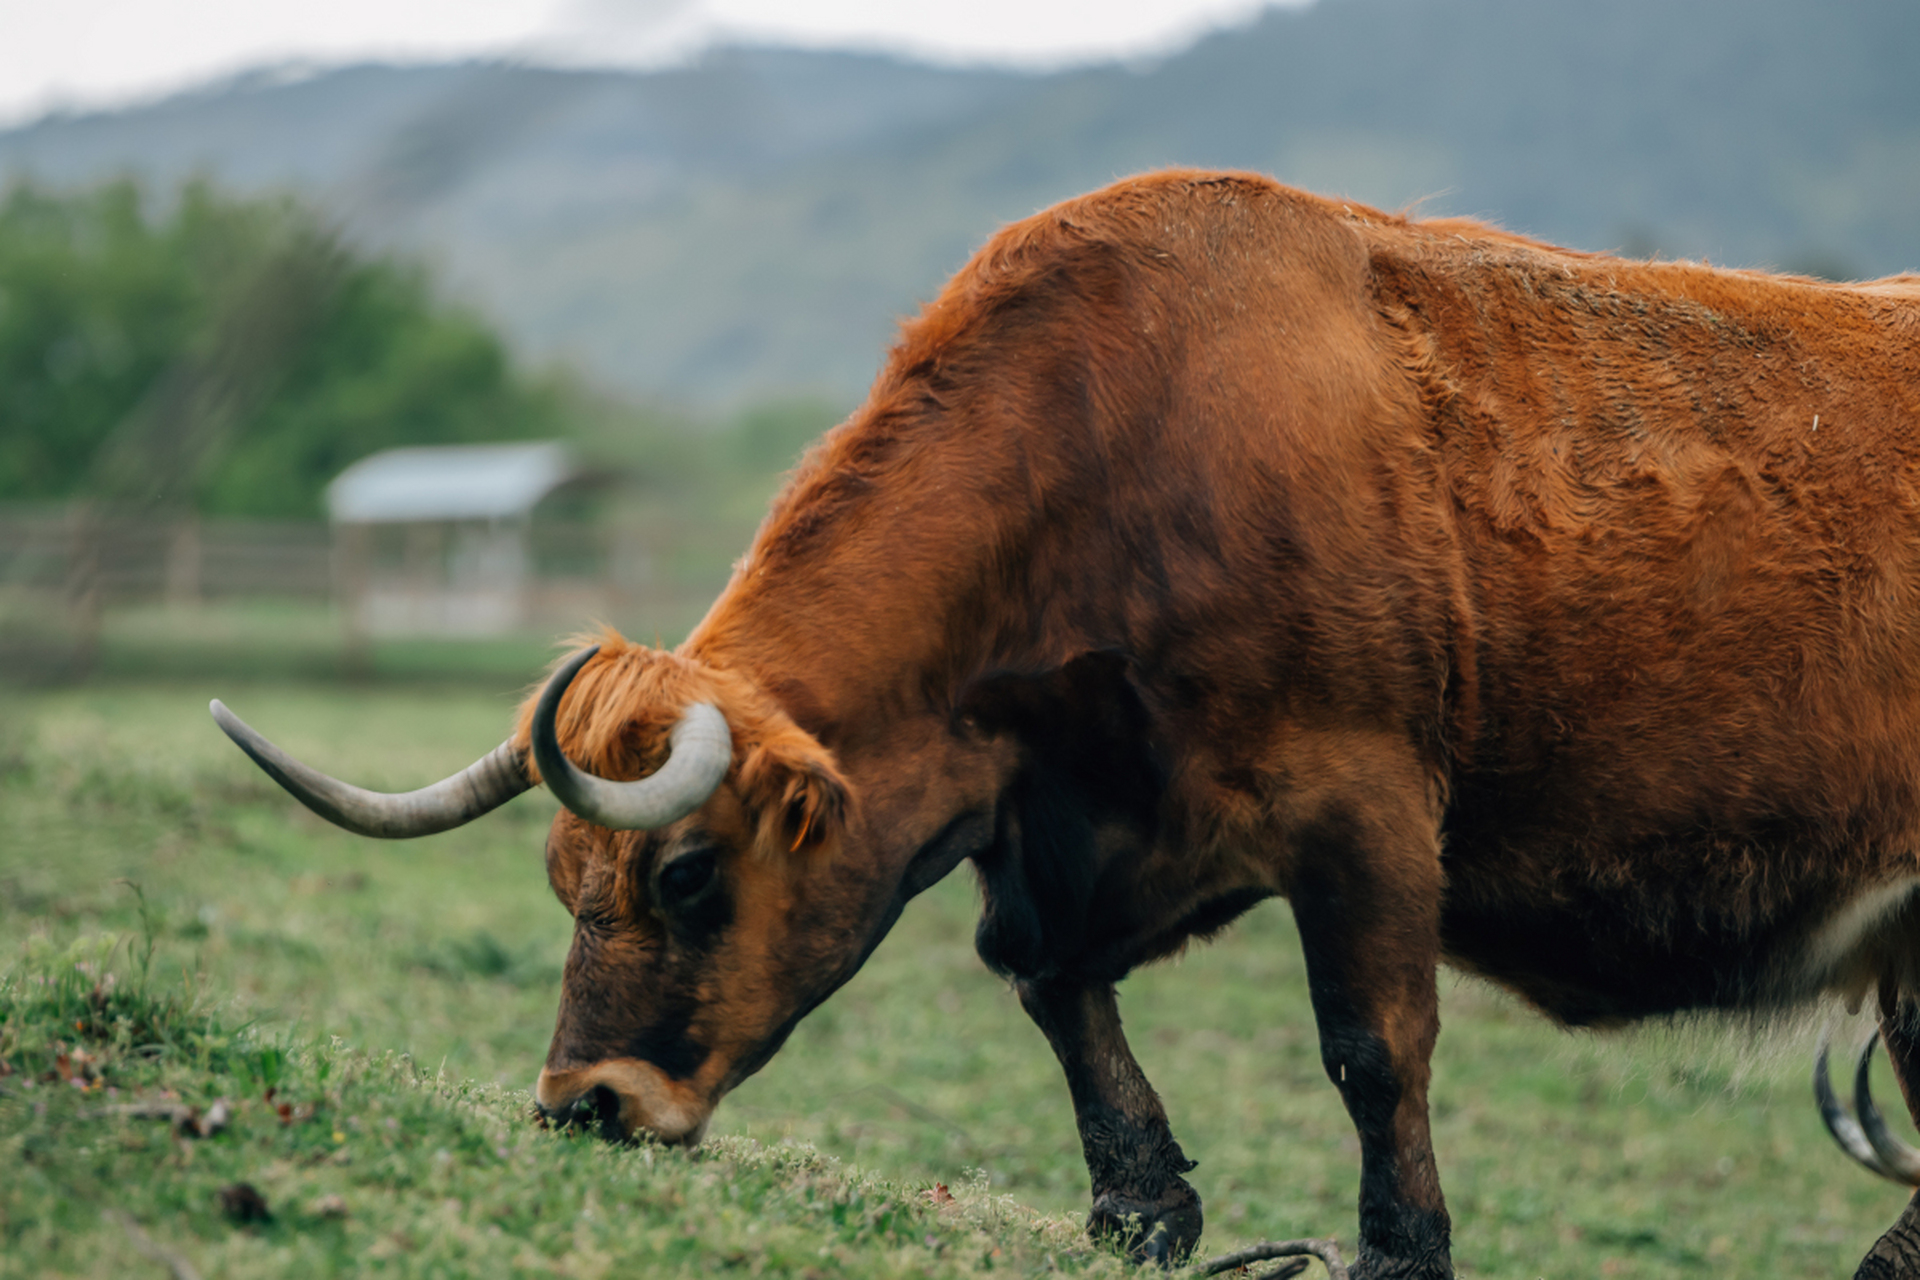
[0,0,1302,121]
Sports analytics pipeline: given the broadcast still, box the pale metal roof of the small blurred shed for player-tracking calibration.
[326,439,582,524]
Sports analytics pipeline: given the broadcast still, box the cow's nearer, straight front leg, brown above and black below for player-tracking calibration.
[1290,809,1453,1280]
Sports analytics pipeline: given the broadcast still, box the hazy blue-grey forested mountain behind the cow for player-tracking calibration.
[0,0,1920,405]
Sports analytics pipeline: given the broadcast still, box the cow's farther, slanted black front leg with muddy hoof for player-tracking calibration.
[1018,979,1200,1265]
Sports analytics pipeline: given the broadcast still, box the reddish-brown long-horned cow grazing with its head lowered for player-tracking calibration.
[214,173,1920,1278]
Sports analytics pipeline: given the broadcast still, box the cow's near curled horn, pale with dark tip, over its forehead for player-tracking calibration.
[532,645,733,831]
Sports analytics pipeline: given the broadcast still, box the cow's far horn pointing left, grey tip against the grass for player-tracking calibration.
[207,699,534,841]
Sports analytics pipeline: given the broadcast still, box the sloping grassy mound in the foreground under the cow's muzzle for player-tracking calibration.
[0,944,1121,1276]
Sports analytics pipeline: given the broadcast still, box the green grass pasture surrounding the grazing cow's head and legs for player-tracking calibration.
[0,670,1905,1278]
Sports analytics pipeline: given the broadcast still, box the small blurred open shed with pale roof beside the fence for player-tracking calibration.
[326,441,597,635]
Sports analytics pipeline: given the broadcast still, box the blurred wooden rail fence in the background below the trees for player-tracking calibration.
[0,509,730,676]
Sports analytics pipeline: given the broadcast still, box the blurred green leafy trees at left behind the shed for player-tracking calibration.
[0,180,578,516]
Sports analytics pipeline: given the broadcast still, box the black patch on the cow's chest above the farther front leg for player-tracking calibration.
[956,652,1165,979]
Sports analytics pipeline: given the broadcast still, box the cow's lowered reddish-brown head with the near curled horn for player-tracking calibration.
[516,639,860,1142]
